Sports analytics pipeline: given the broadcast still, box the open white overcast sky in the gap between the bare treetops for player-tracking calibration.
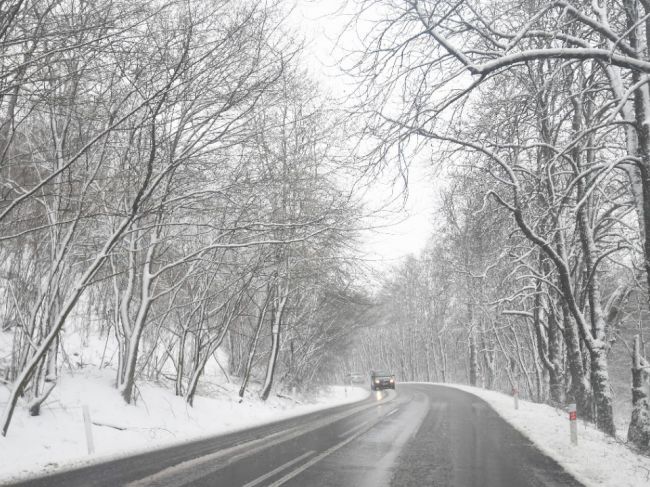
[290,0,437,267]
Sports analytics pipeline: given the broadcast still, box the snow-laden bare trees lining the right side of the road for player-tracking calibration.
[346,0,650,447]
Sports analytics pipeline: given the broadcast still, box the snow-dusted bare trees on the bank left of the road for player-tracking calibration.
[0,0,359,435]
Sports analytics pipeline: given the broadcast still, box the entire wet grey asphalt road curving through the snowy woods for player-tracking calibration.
[5,384,581,487]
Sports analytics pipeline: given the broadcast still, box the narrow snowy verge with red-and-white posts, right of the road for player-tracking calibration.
[410,384,650,487]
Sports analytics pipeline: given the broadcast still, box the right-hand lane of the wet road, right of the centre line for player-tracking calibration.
[276,384,581,487]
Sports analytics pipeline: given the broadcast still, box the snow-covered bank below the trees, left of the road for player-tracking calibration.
[0,368,369,484]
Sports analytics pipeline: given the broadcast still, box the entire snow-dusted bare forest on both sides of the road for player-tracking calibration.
[0,0,650,456]
